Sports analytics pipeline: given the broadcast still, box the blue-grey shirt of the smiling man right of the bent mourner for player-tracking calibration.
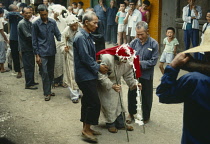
[130,37,159,80]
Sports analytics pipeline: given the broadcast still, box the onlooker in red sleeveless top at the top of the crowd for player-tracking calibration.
[139,0,150,23]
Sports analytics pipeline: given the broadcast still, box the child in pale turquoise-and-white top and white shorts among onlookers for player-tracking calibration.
[115,2,127,45]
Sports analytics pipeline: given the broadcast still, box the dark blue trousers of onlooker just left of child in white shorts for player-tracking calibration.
[106,25,117,44]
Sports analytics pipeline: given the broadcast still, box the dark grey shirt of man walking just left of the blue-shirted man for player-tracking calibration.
[18,19,33,52]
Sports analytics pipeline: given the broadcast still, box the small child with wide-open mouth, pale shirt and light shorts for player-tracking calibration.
[159,27,179,74]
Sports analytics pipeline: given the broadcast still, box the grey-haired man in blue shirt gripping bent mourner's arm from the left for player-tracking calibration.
[73,11,108,142]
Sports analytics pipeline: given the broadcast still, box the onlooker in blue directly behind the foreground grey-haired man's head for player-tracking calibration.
[94,0,107,40]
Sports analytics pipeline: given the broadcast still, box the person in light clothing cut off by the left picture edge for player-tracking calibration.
[0,8,9,73]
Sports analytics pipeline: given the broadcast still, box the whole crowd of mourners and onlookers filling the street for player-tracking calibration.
[0,0,210,144]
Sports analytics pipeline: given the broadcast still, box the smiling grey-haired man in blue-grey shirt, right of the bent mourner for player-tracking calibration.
[127,21,159,124]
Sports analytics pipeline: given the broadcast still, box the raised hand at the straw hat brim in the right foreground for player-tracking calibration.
[170,53,190,68]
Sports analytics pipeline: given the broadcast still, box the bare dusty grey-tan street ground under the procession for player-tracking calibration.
[0,43,186,144]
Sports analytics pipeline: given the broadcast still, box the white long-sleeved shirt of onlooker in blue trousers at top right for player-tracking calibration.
[182,4,202,30]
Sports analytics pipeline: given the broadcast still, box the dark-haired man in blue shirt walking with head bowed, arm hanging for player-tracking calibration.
[32,4,61,101]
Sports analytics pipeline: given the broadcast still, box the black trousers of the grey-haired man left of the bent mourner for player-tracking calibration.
[77,80,101,125]
